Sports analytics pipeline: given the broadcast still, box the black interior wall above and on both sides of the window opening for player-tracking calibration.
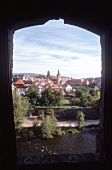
[0,0,112,170]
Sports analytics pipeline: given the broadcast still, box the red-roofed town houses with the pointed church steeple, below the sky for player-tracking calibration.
[12,70,101,94]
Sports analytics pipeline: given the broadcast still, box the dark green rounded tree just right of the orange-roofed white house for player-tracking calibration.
[25,84,40,112]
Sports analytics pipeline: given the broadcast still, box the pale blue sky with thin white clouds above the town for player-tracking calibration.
[13,19,101,78]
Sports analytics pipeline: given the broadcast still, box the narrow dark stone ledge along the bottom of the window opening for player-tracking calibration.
[18,153,101,166]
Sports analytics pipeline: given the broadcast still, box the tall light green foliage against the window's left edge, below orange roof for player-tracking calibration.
[12,91,29,130]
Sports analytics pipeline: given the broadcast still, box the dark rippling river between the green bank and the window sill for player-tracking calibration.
[17,127,98,157]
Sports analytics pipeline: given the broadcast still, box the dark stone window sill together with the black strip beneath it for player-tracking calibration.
[18,153,102,170]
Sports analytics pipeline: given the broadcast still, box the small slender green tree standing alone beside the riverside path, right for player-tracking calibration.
[77,111,85,128]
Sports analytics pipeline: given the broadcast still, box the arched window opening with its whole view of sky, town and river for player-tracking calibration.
[12,20,101,166]
